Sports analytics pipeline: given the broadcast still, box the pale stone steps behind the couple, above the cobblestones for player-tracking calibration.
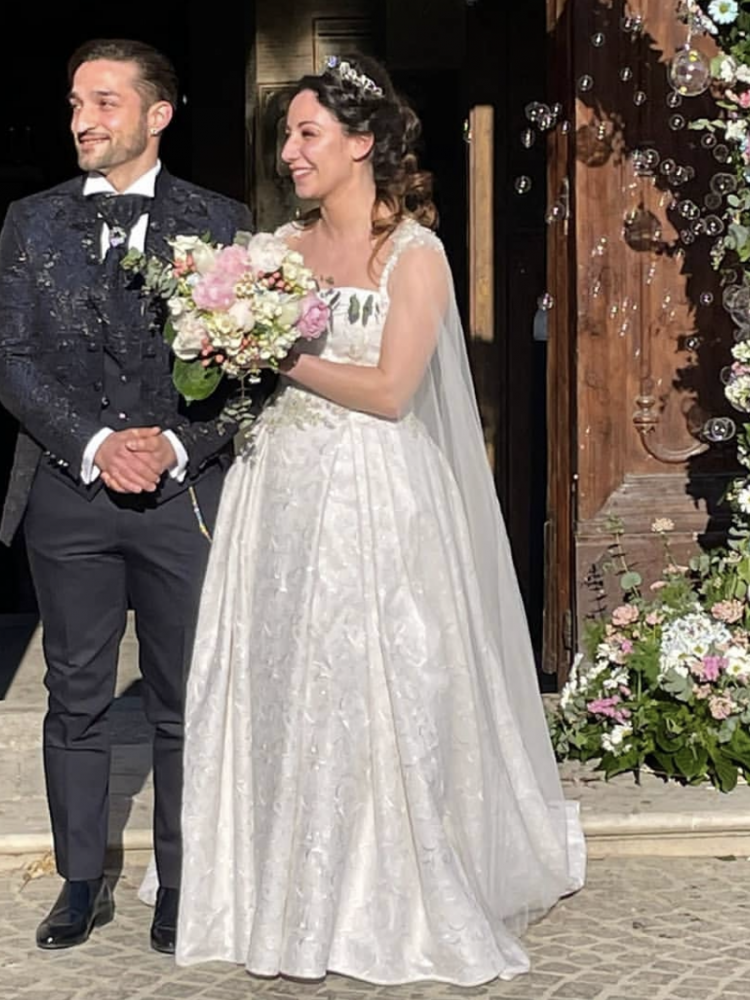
[0,615,750,869]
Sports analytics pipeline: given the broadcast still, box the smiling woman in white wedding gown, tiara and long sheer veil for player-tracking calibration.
[166,50,585,986]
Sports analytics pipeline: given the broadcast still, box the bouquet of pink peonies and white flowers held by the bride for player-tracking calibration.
[123,233,329,402]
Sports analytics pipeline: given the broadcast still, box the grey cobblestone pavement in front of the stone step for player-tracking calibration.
[0,858,750,1000]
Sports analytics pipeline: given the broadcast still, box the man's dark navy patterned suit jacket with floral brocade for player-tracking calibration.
[0,167,251,544]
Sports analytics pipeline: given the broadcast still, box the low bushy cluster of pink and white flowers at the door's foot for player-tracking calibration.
[549,518,750,791]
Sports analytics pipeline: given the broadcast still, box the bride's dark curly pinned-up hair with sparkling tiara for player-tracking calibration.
[294,55,437,245]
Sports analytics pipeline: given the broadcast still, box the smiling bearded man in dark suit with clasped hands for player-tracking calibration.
[0,39,250,952]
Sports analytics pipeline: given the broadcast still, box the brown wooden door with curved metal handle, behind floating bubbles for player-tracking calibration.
[545,0,732,678]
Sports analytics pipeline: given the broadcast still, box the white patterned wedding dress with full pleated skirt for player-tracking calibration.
[164,222,585,986]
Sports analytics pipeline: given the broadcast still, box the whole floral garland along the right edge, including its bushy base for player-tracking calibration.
[549,0,750,791]
